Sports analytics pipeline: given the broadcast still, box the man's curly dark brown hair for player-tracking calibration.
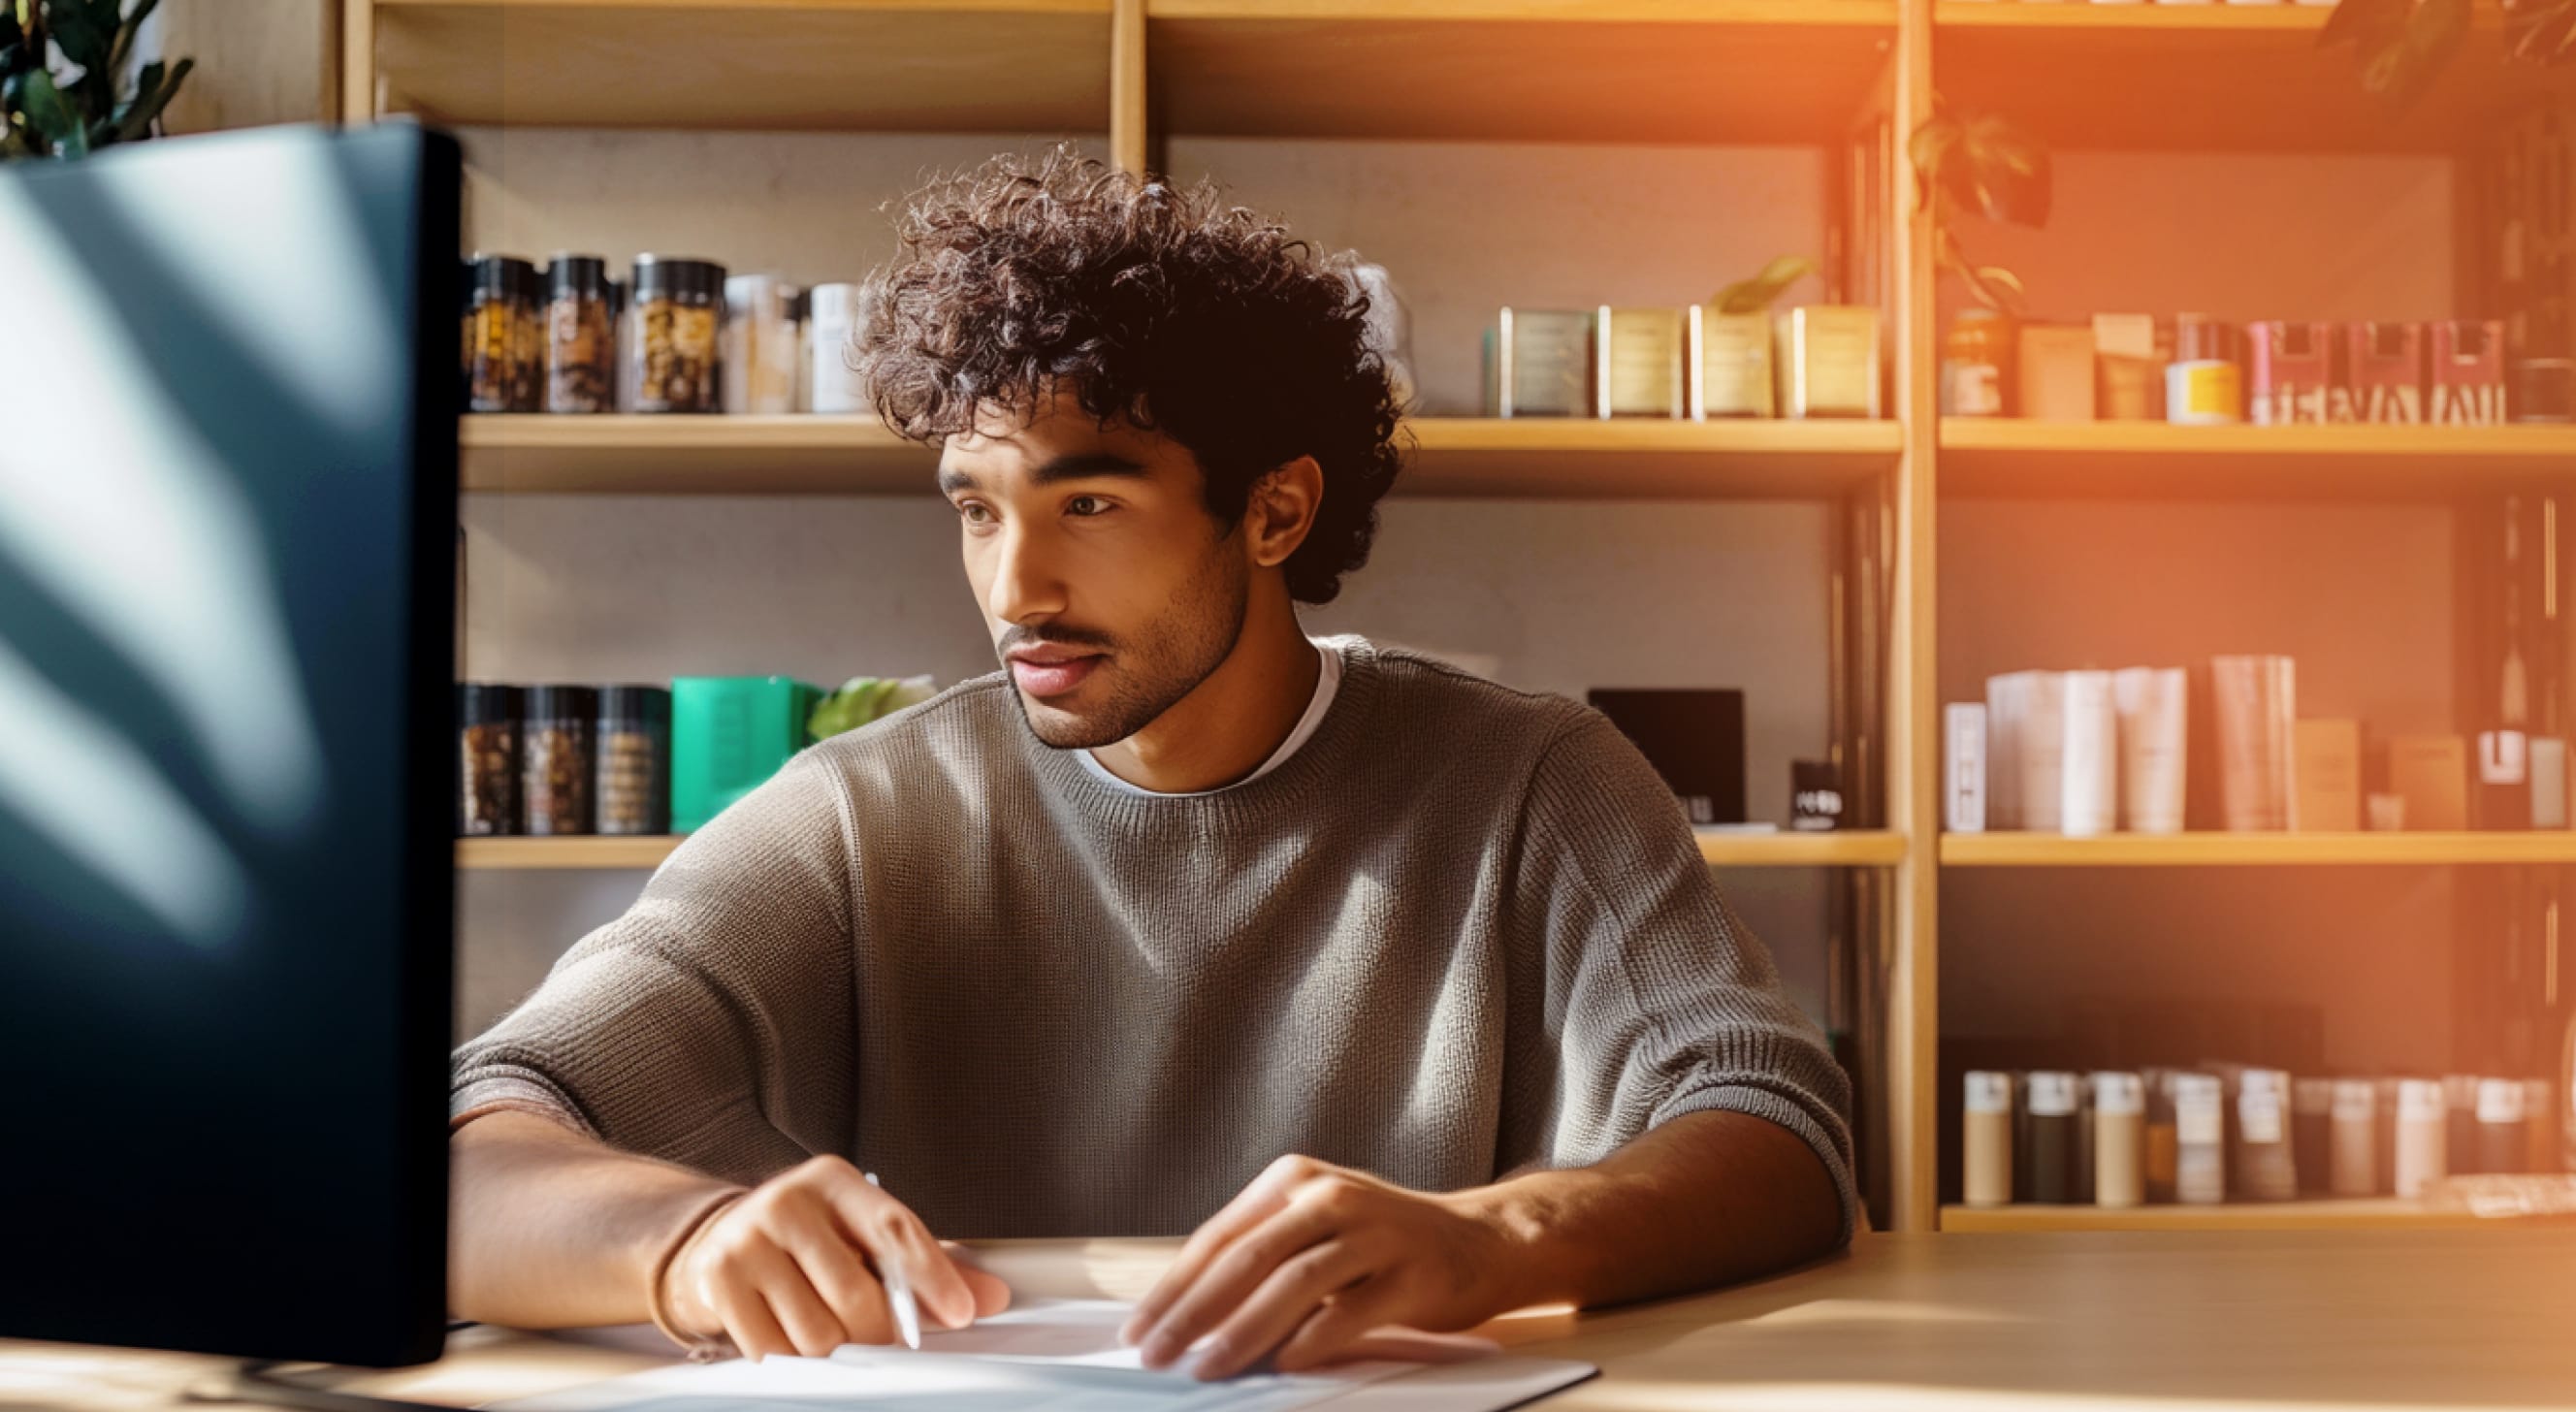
[855,144,1404,603]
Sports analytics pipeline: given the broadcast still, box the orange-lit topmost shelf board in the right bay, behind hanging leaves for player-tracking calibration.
[1932,0,2576,154]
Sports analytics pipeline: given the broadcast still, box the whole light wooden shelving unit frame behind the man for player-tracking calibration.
[330,0,2576,1232]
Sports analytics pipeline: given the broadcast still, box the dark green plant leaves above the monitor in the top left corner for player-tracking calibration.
[0,0,196,162]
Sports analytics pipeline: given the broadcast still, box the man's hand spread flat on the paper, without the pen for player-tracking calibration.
[1120,1157,1523,1378]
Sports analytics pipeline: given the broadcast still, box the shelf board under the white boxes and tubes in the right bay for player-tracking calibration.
[1940,830,2576,868]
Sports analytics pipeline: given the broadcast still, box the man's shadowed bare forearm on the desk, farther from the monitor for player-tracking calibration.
[1458,1110,1842,1309]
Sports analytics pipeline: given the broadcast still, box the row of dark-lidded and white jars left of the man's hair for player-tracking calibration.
[461,252,865,415]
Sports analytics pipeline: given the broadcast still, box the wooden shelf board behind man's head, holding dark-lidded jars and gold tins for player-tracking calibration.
[461,415,1901,499]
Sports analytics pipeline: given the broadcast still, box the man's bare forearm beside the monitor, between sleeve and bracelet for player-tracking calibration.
[448,1110,729,1330]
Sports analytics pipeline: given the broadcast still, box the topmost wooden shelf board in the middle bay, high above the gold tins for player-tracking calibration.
[1146,0,1896,144]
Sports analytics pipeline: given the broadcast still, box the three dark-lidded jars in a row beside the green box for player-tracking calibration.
[456,683,670,838]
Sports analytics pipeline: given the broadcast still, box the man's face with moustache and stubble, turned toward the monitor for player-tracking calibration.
[940,395,1252,750]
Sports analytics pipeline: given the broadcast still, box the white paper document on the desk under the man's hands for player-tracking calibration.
[490,1299,1597,1412]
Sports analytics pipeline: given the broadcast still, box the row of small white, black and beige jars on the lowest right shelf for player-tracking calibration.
[1960,1064,2568,1205]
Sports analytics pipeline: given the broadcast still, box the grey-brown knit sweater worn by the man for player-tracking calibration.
[453,636,1854,1236]
